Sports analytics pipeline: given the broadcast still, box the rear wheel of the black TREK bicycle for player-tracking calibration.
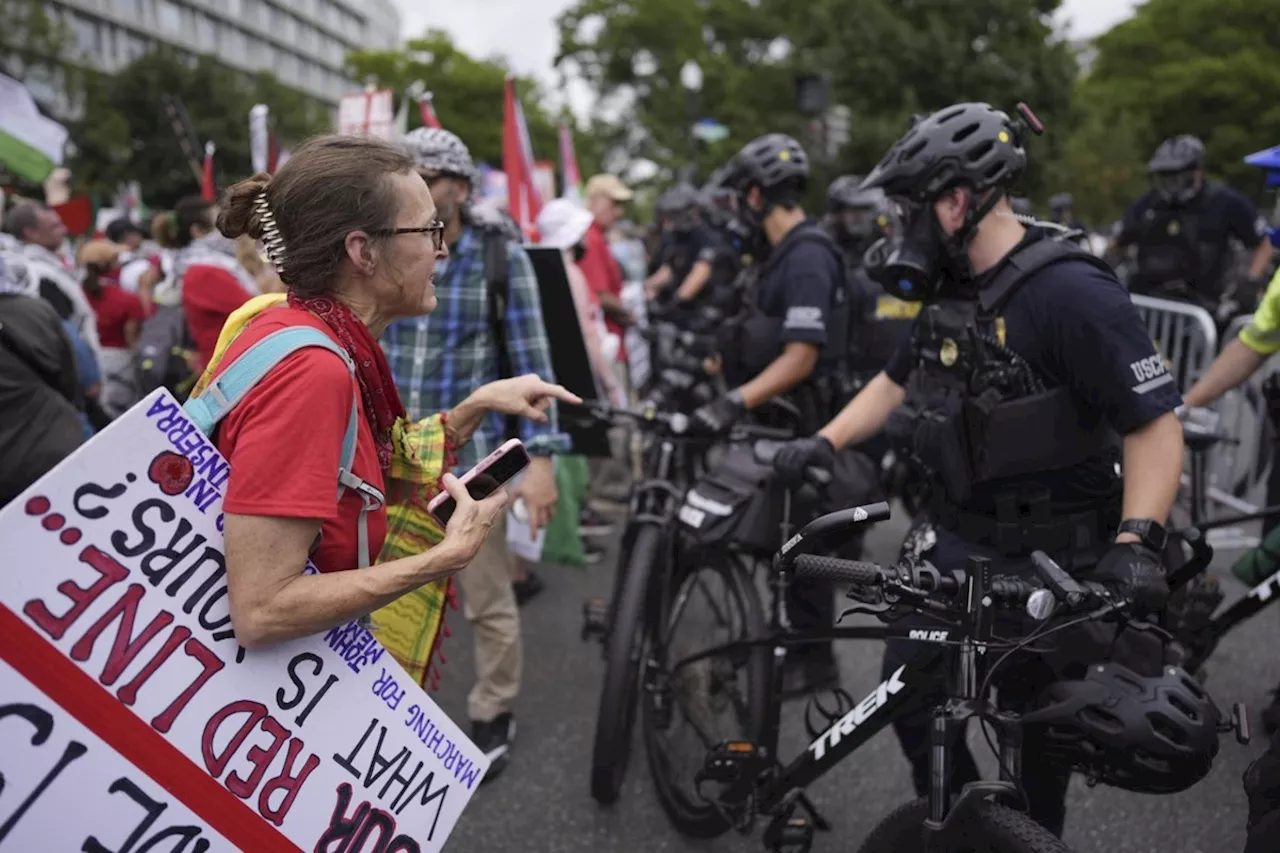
[641,555,769,838]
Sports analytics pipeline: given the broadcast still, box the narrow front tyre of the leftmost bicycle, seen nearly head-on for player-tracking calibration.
[591,524,662,806]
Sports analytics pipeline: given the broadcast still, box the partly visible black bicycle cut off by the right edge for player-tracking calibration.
[1165,409,1280,681]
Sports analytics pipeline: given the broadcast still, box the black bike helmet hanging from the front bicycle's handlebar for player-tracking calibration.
[1021,662,1221,794]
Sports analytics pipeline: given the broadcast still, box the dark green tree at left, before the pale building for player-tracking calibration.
[69,50,332,206]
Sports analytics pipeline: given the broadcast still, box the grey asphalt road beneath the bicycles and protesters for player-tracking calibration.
[435,504,1280,853]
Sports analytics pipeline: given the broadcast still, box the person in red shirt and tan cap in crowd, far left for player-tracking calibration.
[79,240,146,418]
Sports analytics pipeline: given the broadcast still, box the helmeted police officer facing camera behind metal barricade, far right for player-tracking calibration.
[1114,136,1271,313]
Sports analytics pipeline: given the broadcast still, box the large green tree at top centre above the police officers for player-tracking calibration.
[558,0,1075,197]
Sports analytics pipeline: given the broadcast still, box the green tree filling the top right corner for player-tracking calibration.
[1062,0,1280,218]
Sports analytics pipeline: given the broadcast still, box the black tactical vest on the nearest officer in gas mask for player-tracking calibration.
[911,240,1115,506]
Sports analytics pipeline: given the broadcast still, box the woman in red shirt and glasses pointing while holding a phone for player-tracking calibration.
[214,136,581,648]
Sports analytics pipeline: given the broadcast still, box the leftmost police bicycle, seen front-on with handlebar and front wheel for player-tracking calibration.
[562,394,794,804]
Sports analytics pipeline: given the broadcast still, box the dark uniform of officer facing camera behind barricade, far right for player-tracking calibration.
[1116,181,1267,306]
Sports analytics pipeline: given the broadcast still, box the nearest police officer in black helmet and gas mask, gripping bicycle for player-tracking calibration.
[776,104,1183,834]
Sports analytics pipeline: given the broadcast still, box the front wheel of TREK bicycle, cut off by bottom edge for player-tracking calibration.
[859,799,1071,853]
